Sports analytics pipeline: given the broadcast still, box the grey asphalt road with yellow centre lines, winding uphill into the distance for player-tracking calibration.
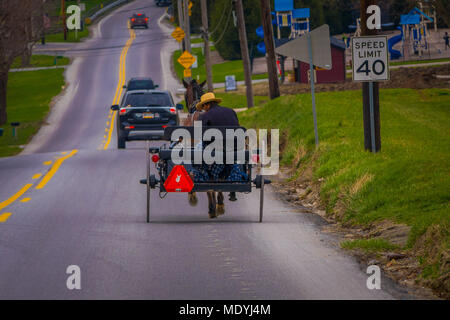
[0,0,407,299]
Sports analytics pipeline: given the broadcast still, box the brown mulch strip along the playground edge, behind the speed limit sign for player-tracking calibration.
[253,64,450,96]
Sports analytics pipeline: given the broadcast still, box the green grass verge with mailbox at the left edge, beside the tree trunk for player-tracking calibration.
[0,69,64,157]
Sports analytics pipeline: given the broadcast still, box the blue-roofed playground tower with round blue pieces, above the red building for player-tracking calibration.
[256,0,310,55]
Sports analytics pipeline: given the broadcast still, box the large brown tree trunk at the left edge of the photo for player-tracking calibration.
[0,0,43,125]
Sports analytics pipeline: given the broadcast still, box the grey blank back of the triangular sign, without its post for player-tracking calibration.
[275,24,332,70]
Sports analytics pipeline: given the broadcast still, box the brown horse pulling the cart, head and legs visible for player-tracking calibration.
[183,79,225,218]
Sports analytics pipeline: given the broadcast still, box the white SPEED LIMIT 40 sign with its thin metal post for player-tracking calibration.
[352,36,389,153]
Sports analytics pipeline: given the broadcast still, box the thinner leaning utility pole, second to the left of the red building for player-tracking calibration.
[235,0,254,108]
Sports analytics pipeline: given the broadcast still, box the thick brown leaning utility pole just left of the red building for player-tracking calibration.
[261,0,280,99]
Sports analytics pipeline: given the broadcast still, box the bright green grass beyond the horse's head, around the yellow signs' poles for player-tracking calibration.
[173,48,267,83]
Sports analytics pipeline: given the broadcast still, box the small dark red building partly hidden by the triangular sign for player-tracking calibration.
[296,37,346,83]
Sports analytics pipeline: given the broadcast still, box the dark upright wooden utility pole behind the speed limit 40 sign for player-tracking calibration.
[360,0,381,152]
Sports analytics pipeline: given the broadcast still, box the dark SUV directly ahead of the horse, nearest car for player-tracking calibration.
[111,90,183,149]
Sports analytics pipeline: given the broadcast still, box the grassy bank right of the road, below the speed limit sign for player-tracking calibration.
[239,89,450,277]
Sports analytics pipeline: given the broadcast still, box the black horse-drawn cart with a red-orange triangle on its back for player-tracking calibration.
[140,127,270,223]
